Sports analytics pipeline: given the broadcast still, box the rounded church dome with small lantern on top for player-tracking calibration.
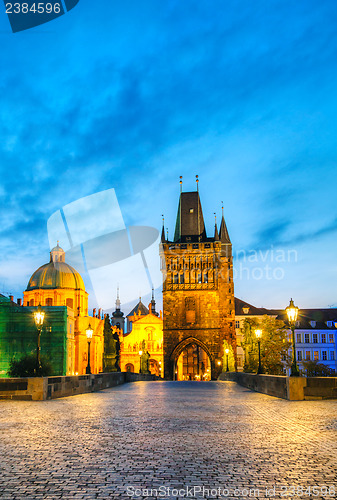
[26,242,85,292]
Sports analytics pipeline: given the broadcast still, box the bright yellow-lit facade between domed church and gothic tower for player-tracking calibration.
[120,299,164,376]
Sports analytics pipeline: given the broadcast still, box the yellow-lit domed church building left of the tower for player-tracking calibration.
[23,242,104,375]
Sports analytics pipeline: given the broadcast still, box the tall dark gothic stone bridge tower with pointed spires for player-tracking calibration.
[160,183,236,380]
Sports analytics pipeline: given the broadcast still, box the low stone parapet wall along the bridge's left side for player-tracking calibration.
[0,372,156,401]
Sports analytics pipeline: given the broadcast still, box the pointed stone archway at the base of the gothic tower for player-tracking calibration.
[170,337,212,381]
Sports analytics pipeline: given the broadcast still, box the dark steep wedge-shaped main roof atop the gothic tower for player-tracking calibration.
[174,191,206,243]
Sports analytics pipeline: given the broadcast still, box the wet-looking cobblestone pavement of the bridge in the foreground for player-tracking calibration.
[0,382,337,500]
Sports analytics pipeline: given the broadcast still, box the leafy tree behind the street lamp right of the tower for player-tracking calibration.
[242,316,291,375]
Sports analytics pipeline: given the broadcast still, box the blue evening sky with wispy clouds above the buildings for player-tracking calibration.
[0,0,337,308]
